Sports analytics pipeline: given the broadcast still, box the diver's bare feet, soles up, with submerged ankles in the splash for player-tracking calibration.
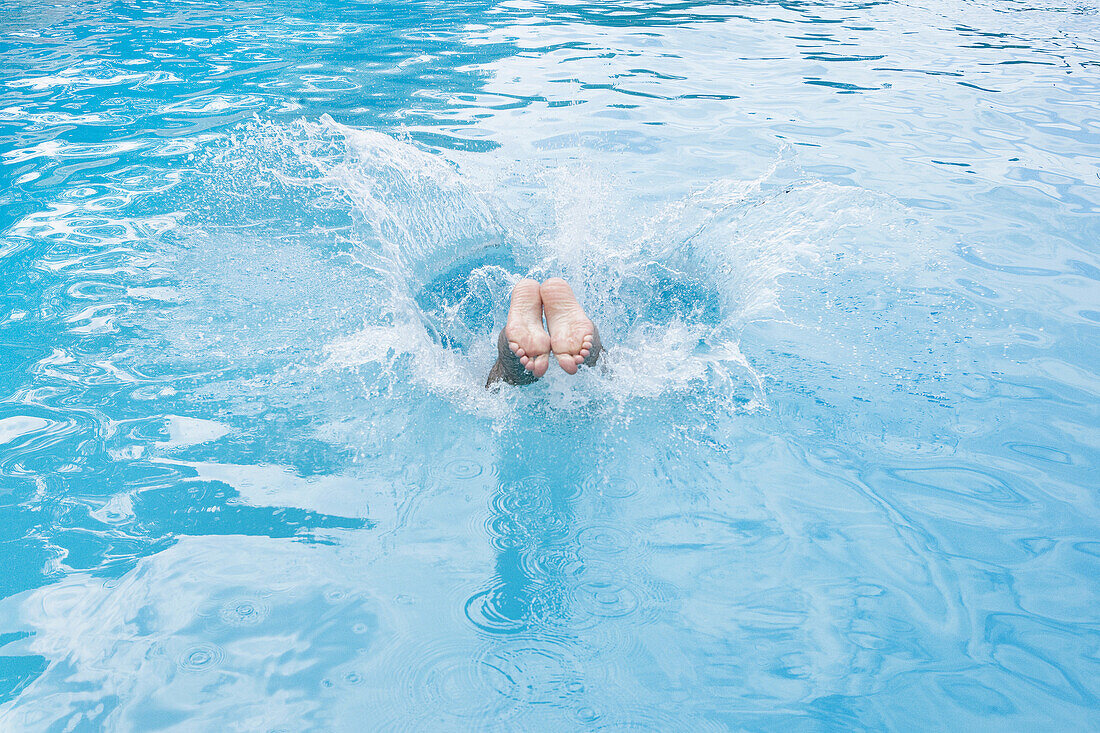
[488,277,602,384]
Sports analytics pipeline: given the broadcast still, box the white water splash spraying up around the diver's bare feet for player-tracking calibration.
[187,116,919,419]
